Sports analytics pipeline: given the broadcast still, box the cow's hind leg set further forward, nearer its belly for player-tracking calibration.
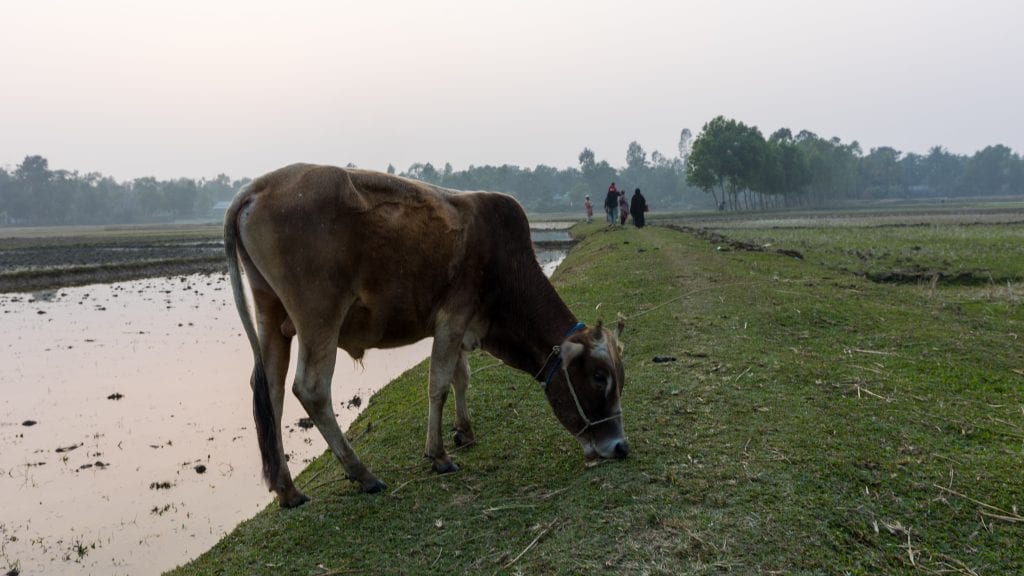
[292,330,387,493]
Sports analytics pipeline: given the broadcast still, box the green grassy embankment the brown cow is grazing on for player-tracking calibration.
[175,220,1024,575]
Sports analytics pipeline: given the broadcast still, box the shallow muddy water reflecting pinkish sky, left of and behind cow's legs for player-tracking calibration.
[0,275,430,575]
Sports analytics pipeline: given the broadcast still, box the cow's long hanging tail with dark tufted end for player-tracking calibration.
[224,186,282,489]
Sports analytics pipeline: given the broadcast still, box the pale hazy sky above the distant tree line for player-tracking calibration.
[0,0,1024,179]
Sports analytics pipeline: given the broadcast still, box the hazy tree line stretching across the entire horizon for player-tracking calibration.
[0,116,1024,225]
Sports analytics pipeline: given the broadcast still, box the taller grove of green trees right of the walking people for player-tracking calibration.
[686,116,1024,210]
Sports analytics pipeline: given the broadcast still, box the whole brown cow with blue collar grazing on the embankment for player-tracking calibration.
[224,164,629,507]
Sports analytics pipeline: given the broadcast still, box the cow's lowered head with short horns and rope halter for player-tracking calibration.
[545,320,630,459]
